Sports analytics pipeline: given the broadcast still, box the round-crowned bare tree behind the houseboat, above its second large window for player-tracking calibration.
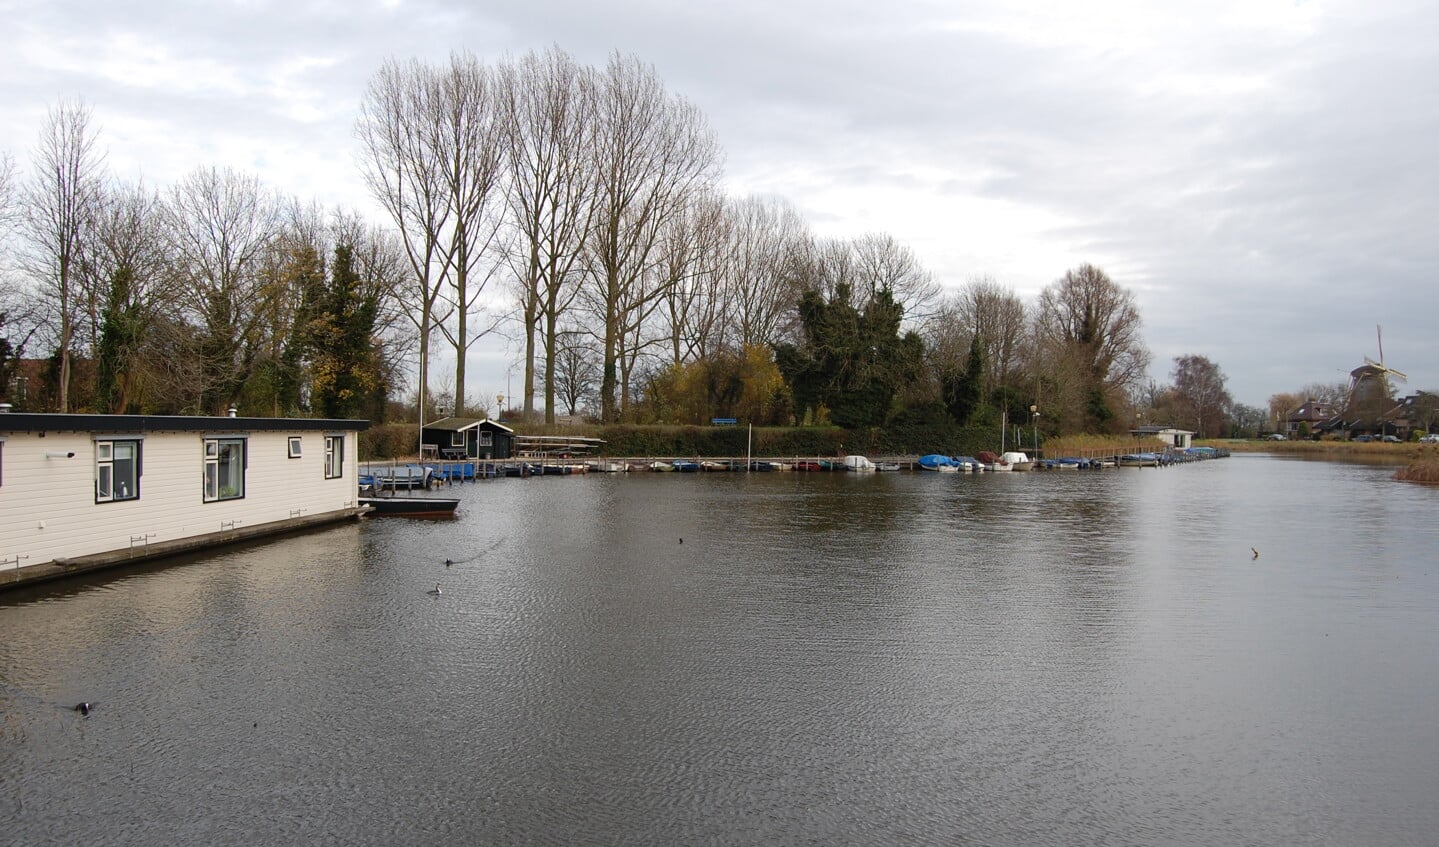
[167,167,282,414]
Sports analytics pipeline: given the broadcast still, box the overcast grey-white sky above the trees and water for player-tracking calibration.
[0,0,1439,407]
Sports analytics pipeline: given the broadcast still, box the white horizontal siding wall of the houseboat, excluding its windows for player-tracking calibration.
[0,431,358,568]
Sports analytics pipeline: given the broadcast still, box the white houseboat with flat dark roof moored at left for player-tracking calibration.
[0,406,370,588]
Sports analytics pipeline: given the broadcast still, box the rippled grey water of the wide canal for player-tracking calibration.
[0,456,1439,846]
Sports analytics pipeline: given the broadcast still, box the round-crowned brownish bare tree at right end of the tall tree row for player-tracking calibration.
[1036,265,1150,429]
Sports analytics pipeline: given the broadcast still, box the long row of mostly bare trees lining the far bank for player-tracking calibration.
[0,47,1232,434]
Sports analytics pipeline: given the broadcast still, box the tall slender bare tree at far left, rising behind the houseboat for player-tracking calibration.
[22,101,104,413]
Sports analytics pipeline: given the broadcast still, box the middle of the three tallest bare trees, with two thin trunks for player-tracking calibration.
[502,47,596,423]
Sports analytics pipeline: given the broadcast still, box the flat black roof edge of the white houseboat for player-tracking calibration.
[0,411,370,433]
